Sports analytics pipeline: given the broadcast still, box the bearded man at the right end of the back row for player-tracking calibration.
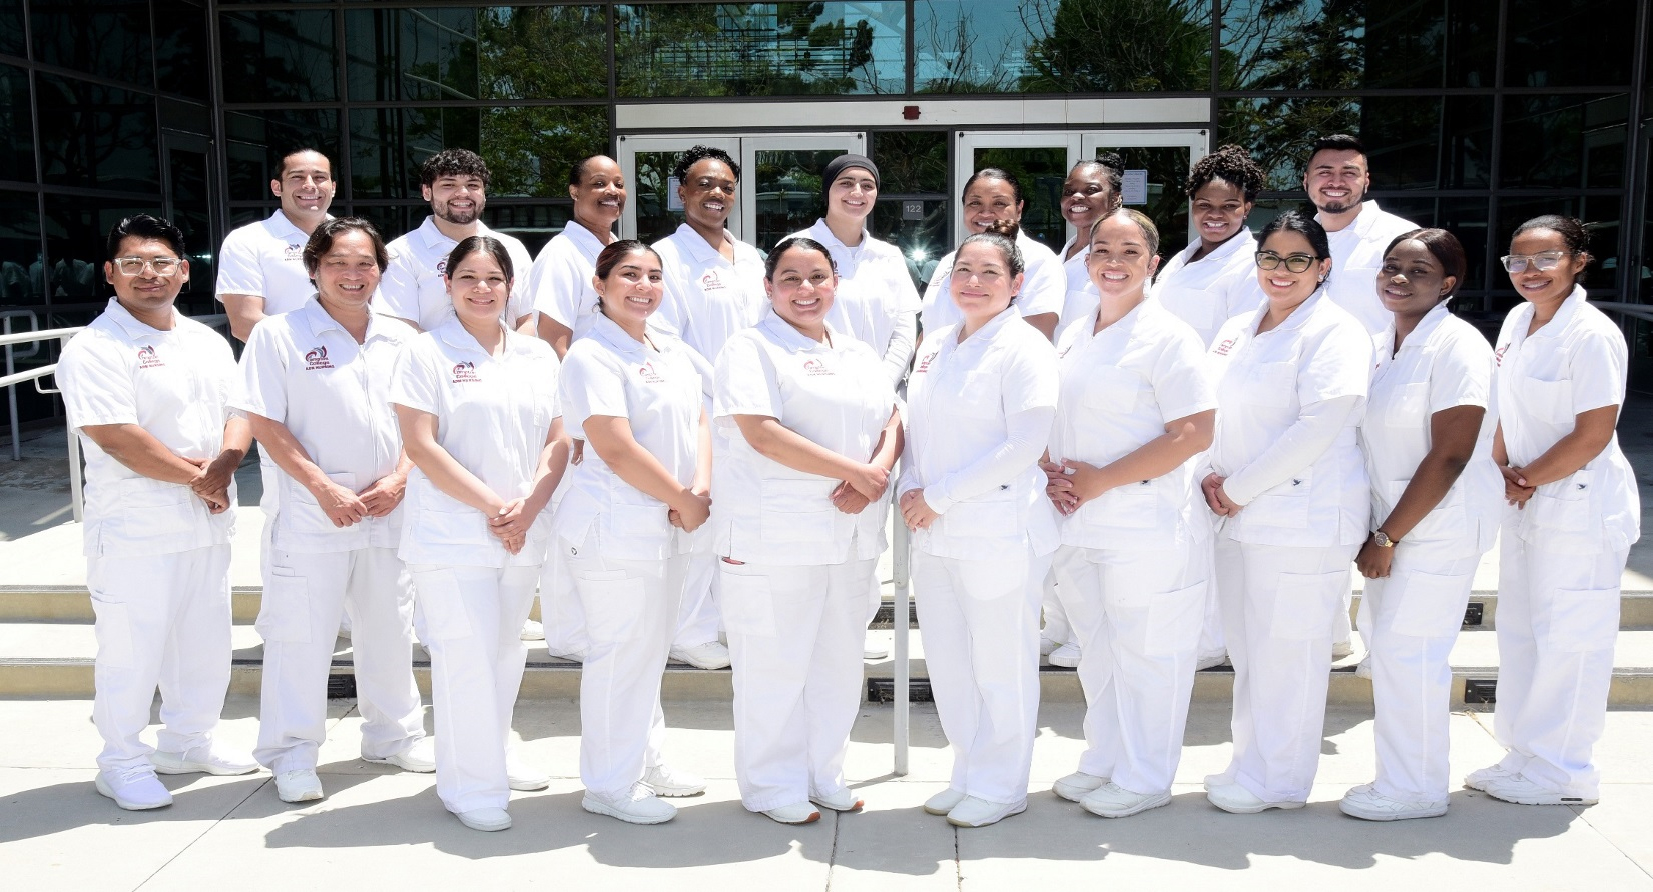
[1303,134,1418,334]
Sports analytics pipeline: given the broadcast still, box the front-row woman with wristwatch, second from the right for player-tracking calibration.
[1341,230,1501,821]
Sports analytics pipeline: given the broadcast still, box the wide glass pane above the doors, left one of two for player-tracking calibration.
[615,0,906,97]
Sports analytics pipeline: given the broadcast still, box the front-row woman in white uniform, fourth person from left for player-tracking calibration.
[557,240,712,824]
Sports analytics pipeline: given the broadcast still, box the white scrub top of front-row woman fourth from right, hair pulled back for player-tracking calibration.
[1050,301,1217,548]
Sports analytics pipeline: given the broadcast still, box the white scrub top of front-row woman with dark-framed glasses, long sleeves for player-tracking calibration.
[1207,291,1372,547]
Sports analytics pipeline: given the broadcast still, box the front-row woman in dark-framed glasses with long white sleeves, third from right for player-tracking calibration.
[1200,211,1372,813]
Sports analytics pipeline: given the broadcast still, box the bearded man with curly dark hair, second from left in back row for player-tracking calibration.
[374,149,534,332]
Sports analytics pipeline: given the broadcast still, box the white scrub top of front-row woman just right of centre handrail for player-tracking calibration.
[896,306,1060,560]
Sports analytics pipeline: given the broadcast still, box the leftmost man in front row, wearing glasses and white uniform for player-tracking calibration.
[58,215,258,809]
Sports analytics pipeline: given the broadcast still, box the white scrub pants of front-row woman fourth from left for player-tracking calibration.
[557,534,689,799]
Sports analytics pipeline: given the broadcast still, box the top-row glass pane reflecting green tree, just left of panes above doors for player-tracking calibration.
[476,7,608,99]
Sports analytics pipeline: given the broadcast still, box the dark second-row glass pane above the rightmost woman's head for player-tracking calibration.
[1499,93,1628,188]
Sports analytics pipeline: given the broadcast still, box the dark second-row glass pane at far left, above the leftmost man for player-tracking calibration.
[35,74,160,193]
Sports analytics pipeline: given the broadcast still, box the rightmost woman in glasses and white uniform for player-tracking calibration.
[1465,216,1641,804]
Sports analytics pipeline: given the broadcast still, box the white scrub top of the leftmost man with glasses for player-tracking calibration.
[58,297,236,557]
